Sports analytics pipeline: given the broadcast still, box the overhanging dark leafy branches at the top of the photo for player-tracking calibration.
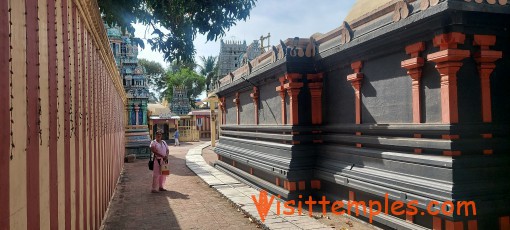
[98,0,256,62]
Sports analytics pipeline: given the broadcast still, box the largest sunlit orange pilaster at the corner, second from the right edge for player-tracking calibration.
[427,32,469,124]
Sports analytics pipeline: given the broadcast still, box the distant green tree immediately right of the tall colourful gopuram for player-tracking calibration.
[138,58,167,100]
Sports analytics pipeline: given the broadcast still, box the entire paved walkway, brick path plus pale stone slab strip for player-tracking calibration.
[101,142,374,230]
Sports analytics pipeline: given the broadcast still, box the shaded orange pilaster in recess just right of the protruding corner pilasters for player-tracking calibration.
[307,73,323,125]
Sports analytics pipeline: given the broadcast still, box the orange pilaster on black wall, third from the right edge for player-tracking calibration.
[401,42,425,123]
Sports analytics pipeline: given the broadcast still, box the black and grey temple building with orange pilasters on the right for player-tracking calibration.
[210,0,510,230]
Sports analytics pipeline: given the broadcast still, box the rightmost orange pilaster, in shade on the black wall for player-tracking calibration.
[473,35,503,122]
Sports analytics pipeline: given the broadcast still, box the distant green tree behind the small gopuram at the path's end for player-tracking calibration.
[165,68,205,108]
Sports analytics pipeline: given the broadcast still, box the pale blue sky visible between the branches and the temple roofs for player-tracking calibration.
[135,0,355,67]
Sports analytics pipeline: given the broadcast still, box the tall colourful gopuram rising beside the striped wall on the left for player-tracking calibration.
[107,26,150,157]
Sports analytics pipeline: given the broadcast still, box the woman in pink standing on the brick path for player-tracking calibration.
[150,130,169,193]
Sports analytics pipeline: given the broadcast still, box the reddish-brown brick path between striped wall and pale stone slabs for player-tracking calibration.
[101,142,257,230]
